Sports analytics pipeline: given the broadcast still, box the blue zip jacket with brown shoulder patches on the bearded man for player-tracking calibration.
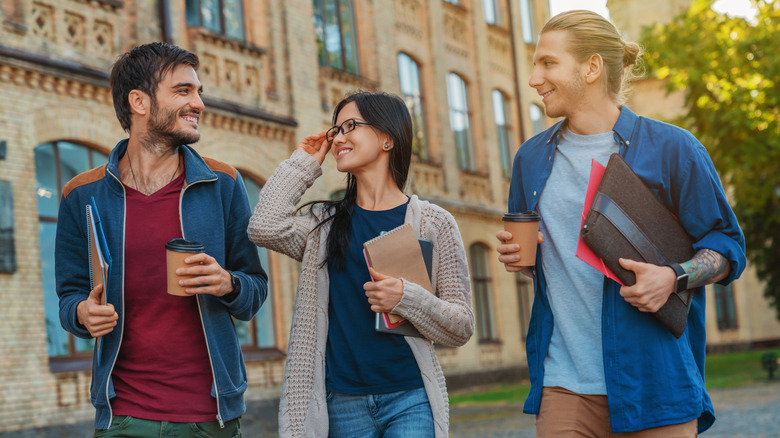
[55,139,268,429]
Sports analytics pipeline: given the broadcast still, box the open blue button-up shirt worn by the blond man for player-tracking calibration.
[509,106,746,433]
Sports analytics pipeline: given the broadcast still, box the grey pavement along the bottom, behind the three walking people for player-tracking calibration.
[0,380,780,438]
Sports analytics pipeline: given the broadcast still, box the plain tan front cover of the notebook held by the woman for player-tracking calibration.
[363,224,433,324]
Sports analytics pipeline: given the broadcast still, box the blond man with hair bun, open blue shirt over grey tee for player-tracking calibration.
[496,11,745,438]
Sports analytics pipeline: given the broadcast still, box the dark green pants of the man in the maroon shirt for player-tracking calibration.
[95,415,241,438]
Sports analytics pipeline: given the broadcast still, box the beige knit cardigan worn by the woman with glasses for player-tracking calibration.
[248,150,474,438]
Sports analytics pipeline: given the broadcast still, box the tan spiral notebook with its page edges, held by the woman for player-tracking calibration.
[363,224,433,337]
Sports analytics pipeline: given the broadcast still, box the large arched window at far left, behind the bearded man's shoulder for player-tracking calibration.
[35,141,108,357]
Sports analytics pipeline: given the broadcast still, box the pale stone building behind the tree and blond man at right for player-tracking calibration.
[607,0,780,351]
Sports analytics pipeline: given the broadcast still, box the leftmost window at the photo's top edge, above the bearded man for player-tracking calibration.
[185,0,244,41]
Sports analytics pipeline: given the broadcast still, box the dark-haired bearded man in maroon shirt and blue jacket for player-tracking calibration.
[55,43,267,437]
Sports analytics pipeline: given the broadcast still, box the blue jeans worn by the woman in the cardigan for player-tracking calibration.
[327,388,434,438]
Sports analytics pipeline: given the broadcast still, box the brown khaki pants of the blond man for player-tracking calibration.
[536,386,698,438]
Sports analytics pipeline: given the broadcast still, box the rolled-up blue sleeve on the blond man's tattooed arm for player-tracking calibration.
[671,132,746,285]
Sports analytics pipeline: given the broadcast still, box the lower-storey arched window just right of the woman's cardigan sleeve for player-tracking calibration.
[469,243,498,343]
